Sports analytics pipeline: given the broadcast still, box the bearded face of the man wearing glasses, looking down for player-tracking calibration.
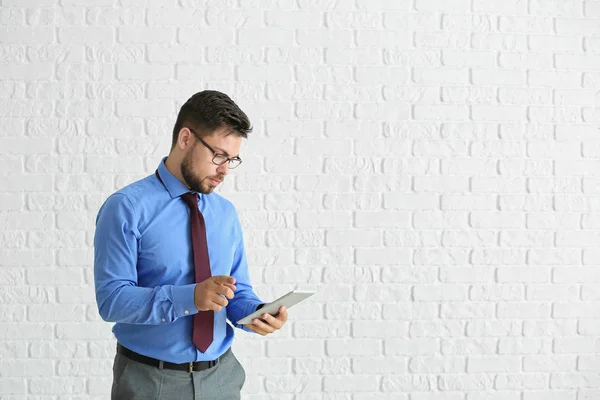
[181,129,242,194]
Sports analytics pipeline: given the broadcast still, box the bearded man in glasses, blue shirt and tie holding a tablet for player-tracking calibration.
[94,91,287,400]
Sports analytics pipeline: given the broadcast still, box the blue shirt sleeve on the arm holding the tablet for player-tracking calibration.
[226,211,264,332]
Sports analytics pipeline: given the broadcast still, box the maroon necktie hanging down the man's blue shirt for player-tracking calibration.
[181,193,214,353]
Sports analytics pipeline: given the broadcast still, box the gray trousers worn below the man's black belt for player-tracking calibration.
[111,346,246,400]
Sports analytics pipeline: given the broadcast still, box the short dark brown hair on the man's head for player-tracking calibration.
[171,90,252,147]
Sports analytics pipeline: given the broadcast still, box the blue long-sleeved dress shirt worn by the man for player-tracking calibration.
[94,157,263,363]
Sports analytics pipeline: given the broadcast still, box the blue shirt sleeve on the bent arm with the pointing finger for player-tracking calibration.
[94,193,198,325]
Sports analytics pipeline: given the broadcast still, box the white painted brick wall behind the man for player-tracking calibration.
[0,0,600,400]
